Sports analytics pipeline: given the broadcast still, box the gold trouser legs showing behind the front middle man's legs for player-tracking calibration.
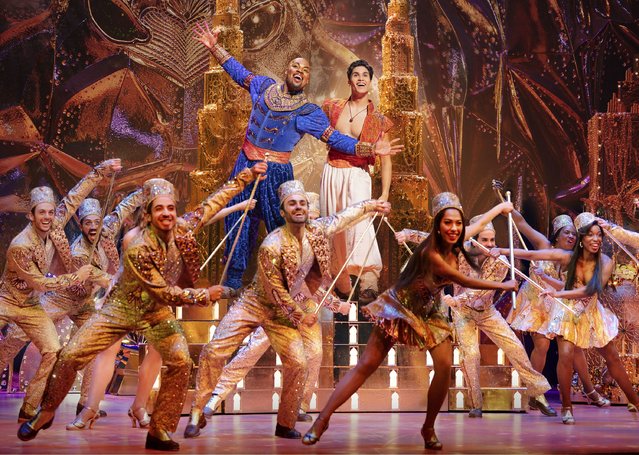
[213,322,322,412]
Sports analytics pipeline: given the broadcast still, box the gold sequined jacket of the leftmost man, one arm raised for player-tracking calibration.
[0,168,102,306]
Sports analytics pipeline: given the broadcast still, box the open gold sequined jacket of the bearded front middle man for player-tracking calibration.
[252,201,374,326]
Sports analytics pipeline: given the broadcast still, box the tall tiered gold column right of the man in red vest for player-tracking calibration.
[375,0,429,288]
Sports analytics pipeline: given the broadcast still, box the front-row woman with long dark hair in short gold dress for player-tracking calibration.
[302,193,517,450]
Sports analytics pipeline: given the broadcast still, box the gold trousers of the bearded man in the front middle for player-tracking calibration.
[193,295,308,428]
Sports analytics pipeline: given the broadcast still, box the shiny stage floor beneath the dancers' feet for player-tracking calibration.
[0,393,639,454]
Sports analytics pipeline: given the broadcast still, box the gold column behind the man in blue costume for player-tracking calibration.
[190,0,251,283]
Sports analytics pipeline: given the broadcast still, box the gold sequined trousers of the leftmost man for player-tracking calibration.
[0,297,60,415]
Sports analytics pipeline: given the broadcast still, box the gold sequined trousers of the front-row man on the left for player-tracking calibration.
[42,301,193,432]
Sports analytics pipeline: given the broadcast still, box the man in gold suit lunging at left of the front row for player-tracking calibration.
[18,163,266,450]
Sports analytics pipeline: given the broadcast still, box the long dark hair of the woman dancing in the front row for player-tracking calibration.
[395,209,477,290]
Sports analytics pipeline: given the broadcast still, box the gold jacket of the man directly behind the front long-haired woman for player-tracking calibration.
[453,254,508,311]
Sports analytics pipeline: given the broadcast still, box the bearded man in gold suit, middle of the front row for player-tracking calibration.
[184,180,390,439]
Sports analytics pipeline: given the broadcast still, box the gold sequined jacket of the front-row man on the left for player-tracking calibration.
[105,169,254,314]
